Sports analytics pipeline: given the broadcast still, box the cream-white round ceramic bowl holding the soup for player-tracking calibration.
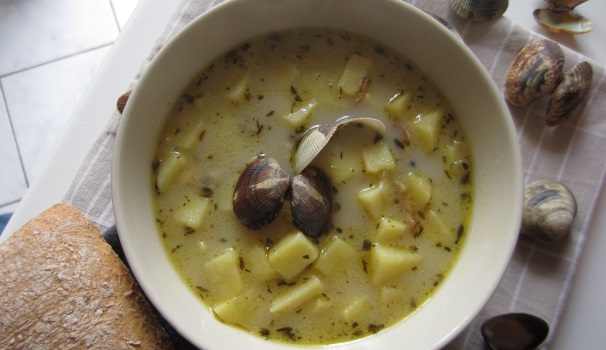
[112,0,522,350]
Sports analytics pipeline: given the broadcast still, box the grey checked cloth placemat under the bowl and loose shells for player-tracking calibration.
[64,0,606,349]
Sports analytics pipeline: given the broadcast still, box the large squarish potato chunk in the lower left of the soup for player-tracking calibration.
[201,249,243,300]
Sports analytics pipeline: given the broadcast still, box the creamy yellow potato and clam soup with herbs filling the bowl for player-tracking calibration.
[151,29,473,345]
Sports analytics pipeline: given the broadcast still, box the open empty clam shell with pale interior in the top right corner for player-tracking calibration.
[533,0,593,35]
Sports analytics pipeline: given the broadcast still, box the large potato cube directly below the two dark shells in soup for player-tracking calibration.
[268,232,319,281]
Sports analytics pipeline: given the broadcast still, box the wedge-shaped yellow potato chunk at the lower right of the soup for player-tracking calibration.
[368,244,421,286]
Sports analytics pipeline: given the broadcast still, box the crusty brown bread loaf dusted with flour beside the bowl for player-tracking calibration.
[0,204,173,350]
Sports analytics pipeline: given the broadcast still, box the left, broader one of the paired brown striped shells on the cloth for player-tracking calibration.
[505,39,564,106]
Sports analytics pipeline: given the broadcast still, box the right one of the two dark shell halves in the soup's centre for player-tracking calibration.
[290,166,333,238]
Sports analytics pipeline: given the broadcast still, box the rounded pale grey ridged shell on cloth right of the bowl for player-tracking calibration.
[521,180,577,242]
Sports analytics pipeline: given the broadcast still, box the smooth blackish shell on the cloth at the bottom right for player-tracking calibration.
[481,313,549,350]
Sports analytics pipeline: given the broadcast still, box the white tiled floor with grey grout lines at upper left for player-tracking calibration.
[0,0,138,214]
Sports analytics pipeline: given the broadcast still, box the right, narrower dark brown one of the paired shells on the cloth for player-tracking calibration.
[545,61,593,126]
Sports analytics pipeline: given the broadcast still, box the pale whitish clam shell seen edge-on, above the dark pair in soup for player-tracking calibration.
[294,117,385,174]
